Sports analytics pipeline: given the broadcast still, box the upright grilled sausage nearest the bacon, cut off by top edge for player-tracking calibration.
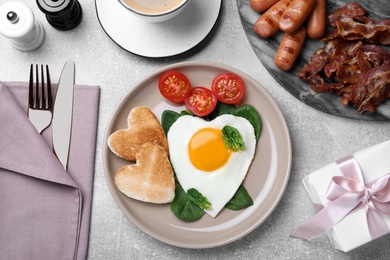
[306,0,326,39]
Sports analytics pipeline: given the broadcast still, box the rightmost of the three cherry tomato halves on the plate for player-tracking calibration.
[211,73,245,104]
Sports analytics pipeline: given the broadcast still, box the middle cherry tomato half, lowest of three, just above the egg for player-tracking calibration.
[184,87,218,116]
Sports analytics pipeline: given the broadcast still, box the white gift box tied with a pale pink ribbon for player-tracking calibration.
[303,141,390,252]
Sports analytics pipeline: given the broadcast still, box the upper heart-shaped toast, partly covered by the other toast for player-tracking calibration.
[107,106,169,161]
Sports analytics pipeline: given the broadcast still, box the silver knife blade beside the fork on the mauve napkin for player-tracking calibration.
[51,61,75,170]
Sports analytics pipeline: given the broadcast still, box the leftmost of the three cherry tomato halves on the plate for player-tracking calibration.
[158,70,191,103]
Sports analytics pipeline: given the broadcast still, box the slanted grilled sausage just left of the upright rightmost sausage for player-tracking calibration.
[279,0,316,33]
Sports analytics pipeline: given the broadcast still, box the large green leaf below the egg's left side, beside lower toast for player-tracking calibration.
[170,183,205,222]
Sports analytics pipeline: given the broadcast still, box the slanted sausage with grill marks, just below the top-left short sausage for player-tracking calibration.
[254,0,292,38]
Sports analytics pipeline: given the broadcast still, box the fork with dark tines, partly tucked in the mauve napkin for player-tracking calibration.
[28,64,53,133]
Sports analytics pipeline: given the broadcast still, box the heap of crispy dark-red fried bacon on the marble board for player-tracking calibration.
[297,3,390,113]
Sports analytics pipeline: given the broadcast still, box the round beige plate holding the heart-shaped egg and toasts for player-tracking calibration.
[103,62,292,248]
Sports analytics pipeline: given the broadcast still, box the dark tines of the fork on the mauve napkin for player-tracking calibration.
[29,64,52,110]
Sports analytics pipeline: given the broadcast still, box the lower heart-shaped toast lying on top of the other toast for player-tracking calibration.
[115,143,175,203]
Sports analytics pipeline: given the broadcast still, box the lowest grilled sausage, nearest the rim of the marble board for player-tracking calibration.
[274,26,306,70]
